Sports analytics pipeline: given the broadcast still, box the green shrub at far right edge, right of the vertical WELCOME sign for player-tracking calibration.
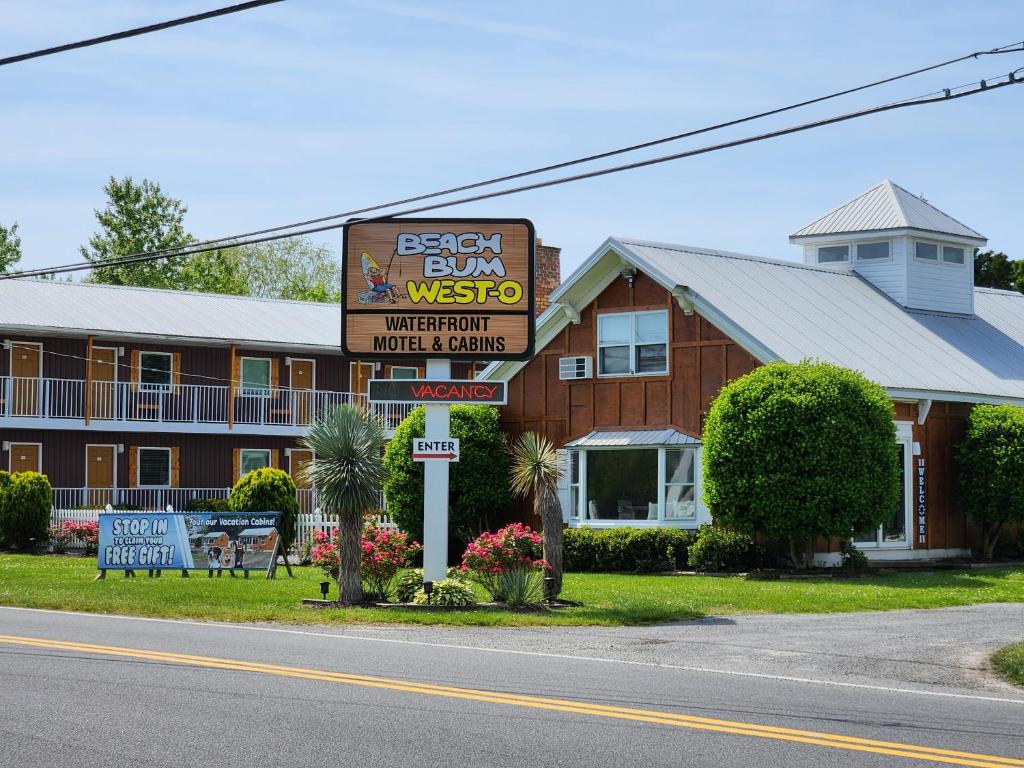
[957,406,1024,559]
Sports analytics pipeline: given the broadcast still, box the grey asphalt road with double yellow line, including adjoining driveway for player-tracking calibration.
[0,605,1024,768]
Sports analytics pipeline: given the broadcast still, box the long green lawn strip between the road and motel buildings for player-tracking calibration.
[0,555,1024,626]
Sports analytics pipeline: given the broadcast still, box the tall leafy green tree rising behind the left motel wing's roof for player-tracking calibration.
[80,176,195,288]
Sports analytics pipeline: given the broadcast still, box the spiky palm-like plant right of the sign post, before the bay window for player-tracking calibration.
[511,432,564,600]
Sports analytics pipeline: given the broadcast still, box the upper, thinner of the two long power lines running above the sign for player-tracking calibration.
[18,41,1024,276]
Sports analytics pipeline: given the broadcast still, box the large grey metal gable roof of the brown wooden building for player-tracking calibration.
[481,238,1024,404]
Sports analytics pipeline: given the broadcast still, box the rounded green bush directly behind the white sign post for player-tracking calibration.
[384,406,511,543]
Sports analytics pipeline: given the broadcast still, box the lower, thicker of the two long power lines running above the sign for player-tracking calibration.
[8,68,1024,280]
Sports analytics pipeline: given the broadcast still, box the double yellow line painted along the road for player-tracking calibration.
[0,635,1024,768]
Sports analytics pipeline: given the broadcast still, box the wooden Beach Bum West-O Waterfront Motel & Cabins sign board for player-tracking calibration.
[341,219,535,360]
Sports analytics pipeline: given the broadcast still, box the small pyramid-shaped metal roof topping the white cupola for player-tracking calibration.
[790,180,985,240]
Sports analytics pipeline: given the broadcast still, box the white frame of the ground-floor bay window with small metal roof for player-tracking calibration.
[566,444,711,530]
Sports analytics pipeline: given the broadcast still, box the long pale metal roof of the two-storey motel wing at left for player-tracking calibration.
[0,280,341,350]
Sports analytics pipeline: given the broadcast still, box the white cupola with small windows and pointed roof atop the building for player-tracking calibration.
[790,180,988,314]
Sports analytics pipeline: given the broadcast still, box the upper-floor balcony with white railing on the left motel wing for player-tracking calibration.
[0,376,413,436]
